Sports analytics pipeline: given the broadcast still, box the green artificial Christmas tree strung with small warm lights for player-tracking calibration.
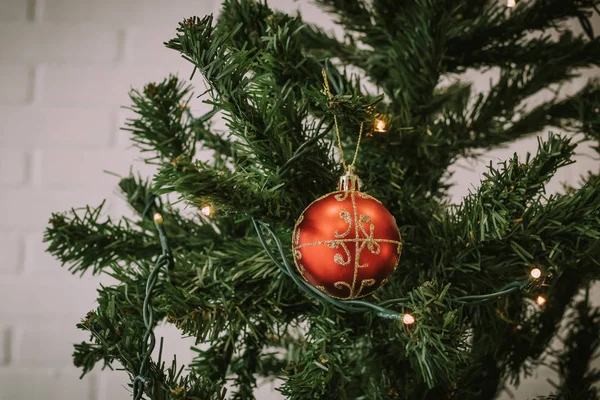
[45,0,600,399]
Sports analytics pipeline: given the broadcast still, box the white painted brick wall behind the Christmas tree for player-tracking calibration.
[0,0,600,400]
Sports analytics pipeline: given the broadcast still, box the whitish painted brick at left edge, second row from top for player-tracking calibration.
[0,22,121,64]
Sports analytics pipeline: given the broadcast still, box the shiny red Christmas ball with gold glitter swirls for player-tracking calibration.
[292,190,402,300]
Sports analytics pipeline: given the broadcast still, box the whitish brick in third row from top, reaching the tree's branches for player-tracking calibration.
[40,66,192,106]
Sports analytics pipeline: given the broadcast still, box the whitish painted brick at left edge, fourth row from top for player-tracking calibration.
[0,106,116,148]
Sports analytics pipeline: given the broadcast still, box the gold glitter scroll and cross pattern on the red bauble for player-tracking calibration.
[292,190,402,300]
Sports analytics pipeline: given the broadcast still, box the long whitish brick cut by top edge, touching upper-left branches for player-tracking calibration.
[44,0,217,27]
